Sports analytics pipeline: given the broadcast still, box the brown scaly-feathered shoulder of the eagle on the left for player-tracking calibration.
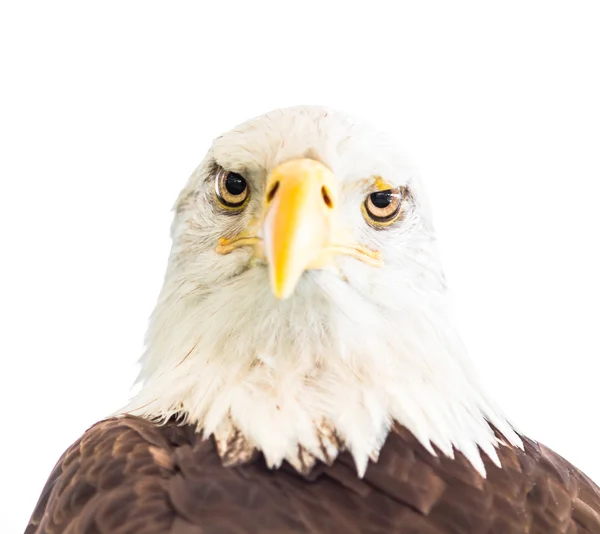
[25,416,193,534]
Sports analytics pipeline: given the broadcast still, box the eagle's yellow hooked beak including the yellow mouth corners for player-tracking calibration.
[216,159,383,299]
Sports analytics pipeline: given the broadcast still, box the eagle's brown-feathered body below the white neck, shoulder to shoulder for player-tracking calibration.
[26,417,600,534]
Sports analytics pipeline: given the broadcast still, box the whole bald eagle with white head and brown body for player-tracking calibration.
[26,107,600,534]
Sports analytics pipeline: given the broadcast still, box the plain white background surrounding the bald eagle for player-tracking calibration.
[0,0,600,534]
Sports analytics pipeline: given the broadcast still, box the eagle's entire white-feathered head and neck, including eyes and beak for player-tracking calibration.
[124,107,518,478]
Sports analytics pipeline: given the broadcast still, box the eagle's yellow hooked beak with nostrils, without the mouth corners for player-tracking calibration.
[262,159,338,299]
